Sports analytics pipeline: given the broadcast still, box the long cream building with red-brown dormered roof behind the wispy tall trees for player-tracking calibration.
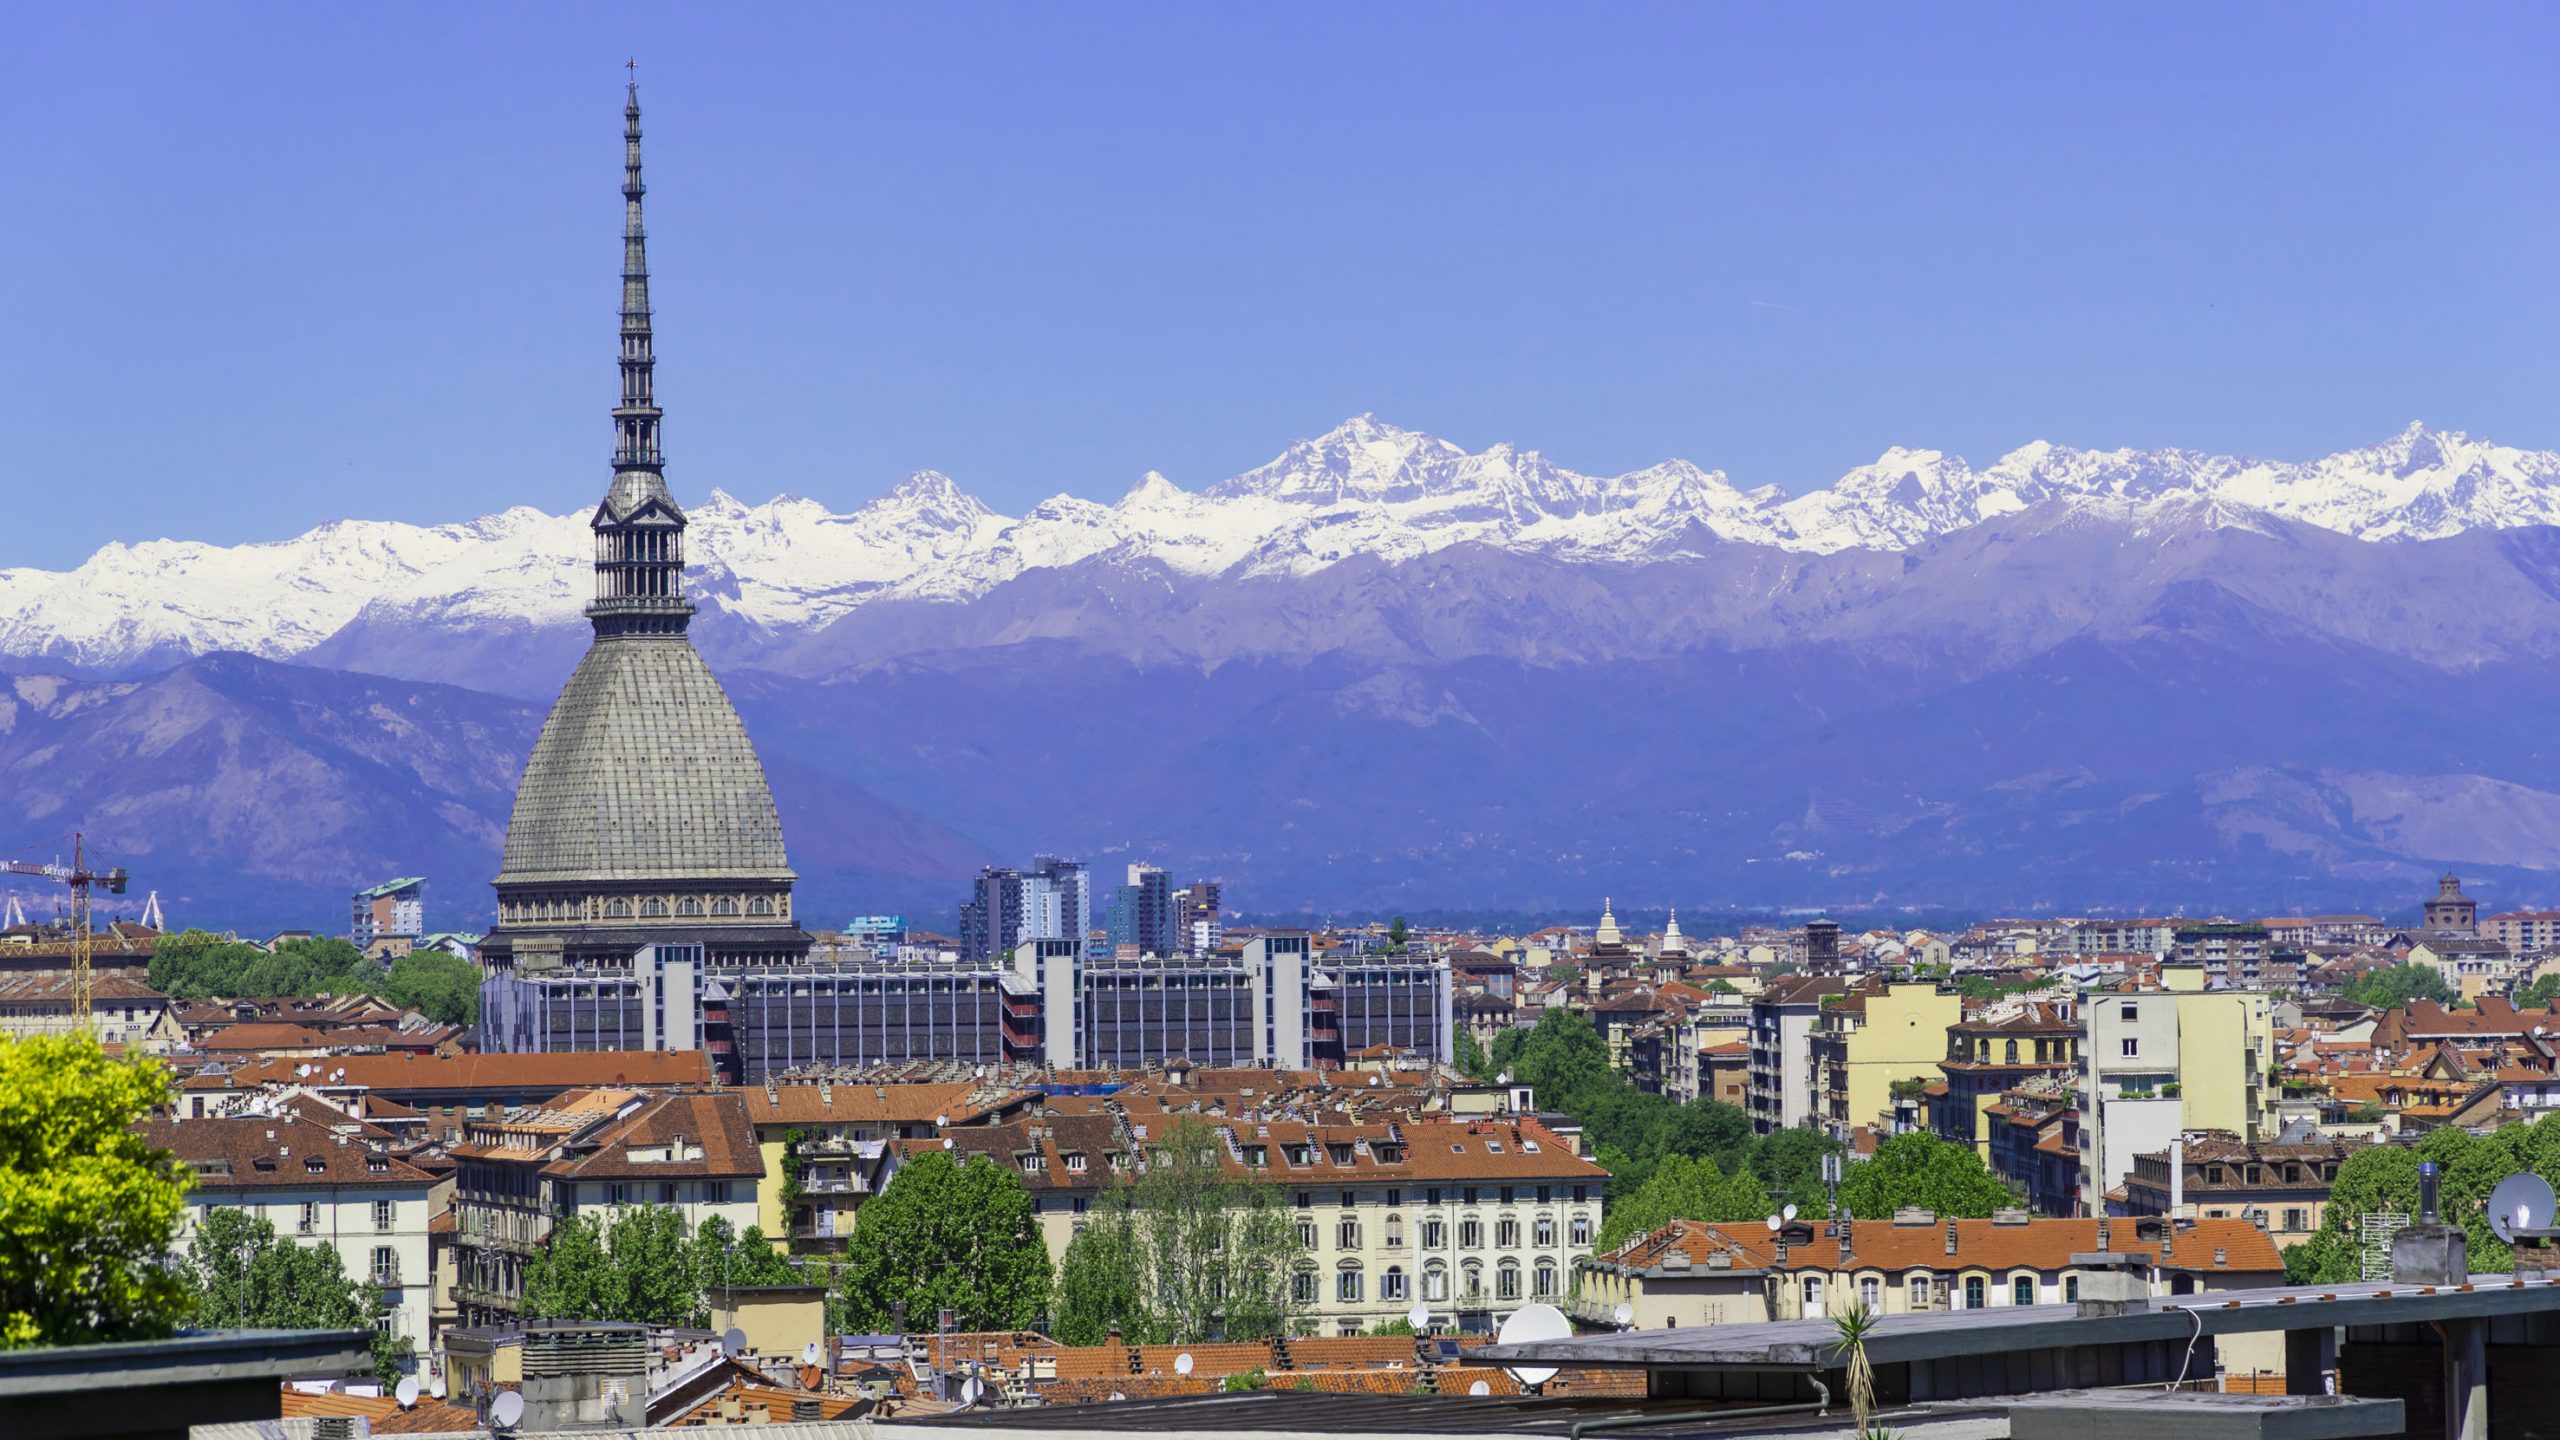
[931,1112,1608,1335]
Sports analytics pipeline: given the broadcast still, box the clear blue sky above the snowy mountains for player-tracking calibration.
[0,0,2560,566]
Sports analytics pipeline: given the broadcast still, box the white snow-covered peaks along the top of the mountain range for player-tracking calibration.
[0,415,2560,669]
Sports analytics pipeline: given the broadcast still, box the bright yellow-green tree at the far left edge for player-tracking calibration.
[0,1035,189,1350]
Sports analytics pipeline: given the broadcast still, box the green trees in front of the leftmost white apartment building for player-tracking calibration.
[184,1204,410,1381]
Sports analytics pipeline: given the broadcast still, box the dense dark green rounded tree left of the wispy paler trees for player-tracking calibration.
[837,1150,1050,1330]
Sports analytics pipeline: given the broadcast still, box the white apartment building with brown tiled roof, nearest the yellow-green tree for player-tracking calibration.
[138,1107,440,1355]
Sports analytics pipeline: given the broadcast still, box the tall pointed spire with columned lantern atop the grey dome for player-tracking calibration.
[586,79,694,638]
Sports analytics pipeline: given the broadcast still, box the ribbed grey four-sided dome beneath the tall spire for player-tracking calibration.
[497,635,791,884]
